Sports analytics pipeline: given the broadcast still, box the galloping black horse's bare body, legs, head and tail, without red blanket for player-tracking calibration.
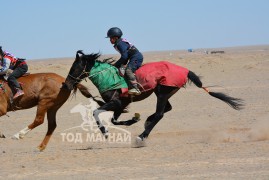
[65,50,243,141]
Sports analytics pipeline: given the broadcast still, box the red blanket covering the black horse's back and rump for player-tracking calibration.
[121,61,189,95]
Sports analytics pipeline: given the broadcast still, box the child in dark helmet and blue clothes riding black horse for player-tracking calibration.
[107,27,143,95]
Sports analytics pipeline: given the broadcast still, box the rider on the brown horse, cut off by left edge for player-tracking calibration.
[0,46,28,99]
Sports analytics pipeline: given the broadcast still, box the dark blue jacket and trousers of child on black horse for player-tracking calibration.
[114,38,143,72]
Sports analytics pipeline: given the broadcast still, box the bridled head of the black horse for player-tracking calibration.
[65,50,100,90]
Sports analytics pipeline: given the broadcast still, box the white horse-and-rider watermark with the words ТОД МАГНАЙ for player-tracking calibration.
[61,98,131,143]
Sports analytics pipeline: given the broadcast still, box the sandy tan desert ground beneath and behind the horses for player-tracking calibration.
[0,46,269,180]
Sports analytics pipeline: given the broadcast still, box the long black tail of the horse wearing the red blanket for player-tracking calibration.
[188,71,244,110]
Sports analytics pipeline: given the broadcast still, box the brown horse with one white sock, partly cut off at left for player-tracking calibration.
[0,73,92,151]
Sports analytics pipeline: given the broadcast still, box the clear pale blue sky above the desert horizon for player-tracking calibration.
[0,0,269,59]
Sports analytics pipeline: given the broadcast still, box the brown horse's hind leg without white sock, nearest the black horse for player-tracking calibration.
[38,109,58,151]
